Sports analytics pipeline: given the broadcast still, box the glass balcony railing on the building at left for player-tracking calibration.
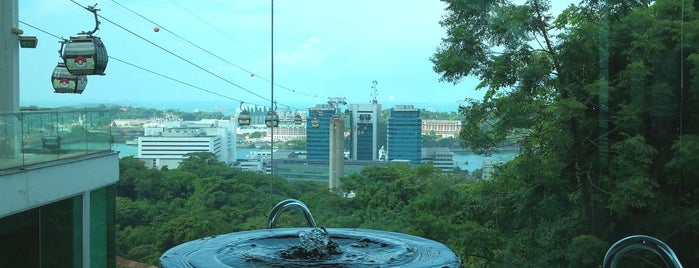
[0,109,112,170]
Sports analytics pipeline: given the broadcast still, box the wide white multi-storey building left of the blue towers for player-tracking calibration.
[137,119,236,168]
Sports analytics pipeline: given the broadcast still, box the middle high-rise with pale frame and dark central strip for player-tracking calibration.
[349,102,381,161]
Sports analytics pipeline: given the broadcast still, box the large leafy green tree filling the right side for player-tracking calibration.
[432,0,699,266]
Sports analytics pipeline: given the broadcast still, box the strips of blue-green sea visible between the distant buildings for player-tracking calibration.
[112,143,517,172]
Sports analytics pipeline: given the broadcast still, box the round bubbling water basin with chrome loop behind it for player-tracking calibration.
[160,199,461,268]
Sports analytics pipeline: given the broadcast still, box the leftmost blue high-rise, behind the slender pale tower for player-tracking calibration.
[306,104,336,160]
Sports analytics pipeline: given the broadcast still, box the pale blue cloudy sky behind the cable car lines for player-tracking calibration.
[19,0,483,111]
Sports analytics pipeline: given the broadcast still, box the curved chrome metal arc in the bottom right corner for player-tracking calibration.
[602,235,682,268]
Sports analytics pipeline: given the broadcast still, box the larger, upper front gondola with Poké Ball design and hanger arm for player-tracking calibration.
[59,3,109,75]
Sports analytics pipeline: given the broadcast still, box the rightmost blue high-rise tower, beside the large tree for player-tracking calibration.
[386,105,422,164]
